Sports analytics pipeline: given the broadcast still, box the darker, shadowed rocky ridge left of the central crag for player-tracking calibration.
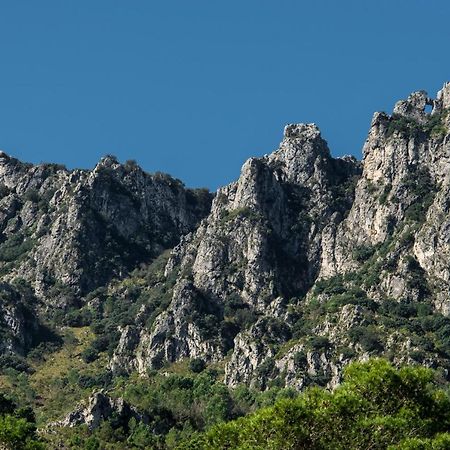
[0,153,212,353]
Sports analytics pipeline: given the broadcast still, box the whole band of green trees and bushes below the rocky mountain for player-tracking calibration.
[6,359,450,450]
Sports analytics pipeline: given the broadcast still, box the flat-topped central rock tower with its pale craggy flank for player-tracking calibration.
[113,124,360,373]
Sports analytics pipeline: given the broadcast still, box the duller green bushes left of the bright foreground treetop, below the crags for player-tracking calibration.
[42,366,297,450]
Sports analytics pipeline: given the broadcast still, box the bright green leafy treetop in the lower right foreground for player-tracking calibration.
[176,360,450,450]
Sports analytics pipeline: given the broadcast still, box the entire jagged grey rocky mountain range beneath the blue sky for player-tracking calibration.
[0,83,450,436]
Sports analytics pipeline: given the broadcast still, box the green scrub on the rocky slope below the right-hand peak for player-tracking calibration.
[291,219,450,370]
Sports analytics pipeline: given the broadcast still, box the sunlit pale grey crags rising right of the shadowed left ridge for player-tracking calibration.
[112,84,450,387]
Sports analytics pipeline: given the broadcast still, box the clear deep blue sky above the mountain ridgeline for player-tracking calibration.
[0,0,450,189]
